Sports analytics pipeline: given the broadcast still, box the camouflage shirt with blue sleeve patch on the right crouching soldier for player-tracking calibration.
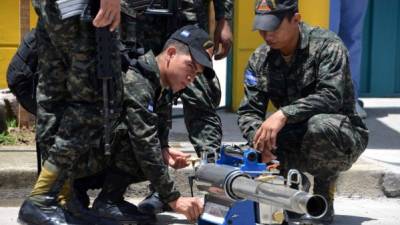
[238,23,365,143]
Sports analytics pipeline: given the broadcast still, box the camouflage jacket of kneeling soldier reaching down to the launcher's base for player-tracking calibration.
[114,51,180,202]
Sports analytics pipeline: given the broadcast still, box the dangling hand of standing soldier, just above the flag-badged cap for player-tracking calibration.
[214,19,232,60]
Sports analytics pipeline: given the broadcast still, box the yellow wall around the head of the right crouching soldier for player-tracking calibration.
[232,0,329,111]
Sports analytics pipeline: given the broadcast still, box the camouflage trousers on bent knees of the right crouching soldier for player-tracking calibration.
[276,114,368,185]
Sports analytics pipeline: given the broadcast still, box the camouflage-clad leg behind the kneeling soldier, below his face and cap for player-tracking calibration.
[181,76,222,156]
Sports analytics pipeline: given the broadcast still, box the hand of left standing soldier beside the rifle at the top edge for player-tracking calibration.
[93,0,121,31]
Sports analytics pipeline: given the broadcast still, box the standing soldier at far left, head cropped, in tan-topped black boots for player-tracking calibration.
[18,0,122,225]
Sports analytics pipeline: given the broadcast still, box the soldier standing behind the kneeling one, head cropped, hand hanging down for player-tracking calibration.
[105,0,233,215]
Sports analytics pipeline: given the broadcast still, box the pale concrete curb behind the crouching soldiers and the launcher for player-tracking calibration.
[0,142,400,205]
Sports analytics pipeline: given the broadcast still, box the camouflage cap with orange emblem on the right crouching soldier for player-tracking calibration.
[253,0,298,31]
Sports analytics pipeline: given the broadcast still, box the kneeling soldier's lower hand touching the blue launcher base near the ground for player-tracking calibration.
[168,197,204,222]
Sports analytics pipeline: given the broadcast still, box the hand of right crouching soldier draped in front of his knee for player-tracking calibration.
[253,110,287,160]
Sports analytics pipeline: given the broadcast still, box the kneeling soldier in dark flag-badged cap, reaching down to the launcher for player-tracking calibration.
[89,25,214,221]
